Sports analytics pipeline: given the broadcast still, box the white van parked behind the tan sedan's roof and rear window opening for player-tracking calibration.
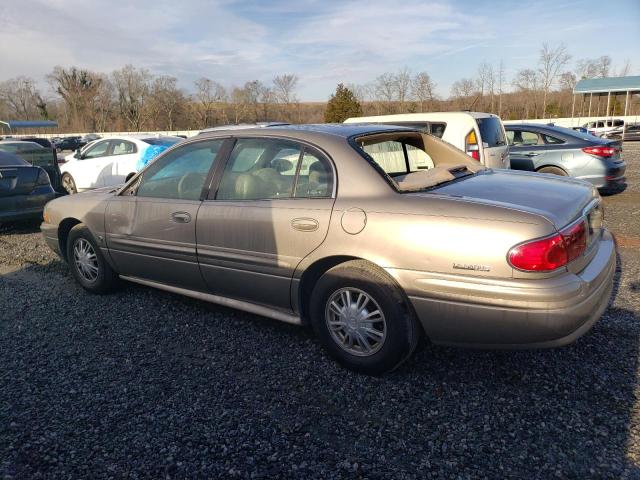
[344,112,509,168]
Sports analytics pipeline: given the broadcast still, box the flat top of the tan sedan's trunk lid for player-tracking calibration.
[420,170,598,229]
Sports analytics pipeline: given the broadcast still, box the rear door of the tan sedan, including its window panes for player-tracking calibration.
[196,137,335,311]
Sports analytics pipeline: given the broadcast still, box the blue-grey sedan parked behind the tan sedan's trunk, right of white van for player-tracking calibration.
[506,123,626,188]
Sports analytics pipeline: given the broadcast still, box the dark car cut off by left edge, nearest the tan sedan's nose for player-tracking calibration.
[0,151,55,223]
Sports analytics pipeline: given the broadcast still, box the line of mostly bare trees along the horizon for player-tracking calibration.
[0,43,638,132]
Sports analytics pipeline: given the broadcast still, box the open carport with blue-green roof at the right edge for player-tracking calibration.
[571,76,640,118]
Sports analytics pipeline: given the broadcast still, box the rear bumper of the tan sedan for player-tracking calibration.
[389,231,616,348]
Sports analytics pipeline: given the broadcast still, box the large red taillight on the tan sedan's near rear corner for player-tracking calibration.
[508,220,587,272]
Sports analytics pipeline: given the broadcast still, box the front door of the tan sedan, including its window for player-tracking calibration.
[105,139,224,290]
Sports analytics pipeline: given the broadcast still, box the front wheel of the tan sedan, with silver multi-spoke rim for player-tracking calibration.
[67,224,119,293]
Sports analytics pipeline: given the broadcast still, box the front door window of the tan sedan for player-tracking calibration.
[137,139,224,200]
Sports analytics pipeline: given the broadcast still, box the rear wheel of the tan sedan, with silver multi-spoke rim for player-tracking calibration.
[309,260,420,375]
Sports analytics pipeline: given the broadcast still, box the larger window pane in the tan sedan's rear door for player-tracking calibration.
[216,138,302,200]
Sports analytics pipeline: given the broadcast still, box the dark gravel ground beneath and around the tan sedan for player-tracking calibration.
[0,144,640,479]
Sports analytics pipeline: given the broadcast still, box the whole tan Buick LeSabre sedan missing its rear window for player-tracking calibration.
[42,124,616,374]
